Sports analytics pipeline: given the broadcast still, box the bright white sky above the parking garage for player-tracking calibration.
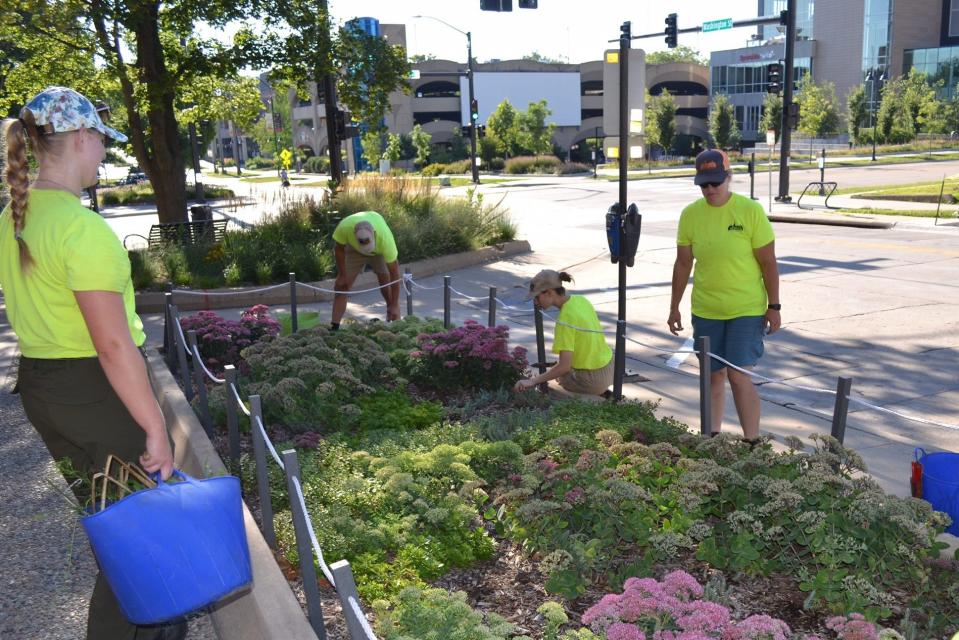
[329,0,758,63]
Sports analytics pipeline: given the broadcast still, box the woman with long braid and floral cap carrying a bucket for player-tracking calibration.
[0,87,186,640]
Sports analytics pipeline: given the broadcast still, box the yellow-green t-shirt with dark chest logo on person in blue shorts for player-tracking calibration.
[676,193,776,320]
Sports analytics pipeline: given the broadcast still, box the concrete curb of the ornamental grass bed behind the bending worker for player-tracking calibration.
[135,240,532,313]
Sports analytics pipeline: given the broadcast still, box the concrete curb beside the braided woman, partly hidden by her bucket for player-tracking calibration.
[147,349,316,640]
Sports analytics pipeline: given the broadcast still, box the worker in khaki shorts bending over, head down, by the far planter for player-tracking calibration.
[330,211,400,331]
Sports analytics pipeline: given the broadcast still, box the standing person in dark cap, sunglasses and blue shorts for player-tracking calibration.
[666,149,782,445]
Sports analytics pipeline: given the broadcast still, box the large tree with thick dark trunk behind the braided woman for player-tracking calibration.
[3,0,252,222]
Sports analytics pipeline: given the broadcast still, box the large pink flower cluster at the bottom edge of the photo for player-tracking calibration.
[582,571,790,640]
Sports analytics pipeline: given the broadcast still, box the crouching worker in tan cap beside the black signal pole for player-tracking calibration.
[514,269,613,396]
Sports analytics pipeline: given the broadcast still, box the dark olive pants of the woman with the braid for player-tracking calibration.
[17,357,186,640]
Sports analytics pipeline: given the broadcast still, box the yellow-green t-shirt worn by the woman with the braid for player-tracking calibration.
[0,189,146,359]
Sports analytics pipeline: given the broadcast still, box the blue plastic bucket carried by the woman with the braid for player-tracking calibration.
[81,471,253,624]
